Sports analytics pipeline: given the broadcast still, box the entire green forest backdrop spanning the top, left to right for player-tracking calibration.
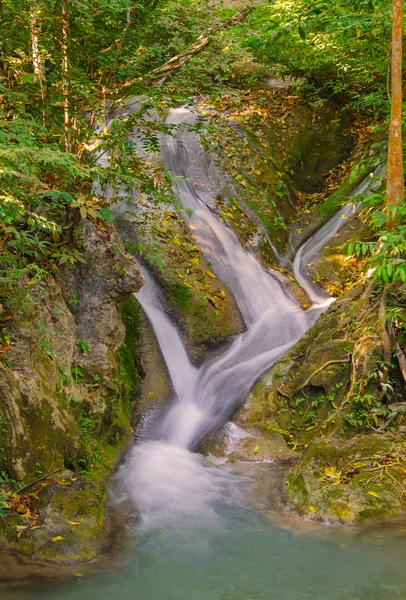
[0,0,406,310]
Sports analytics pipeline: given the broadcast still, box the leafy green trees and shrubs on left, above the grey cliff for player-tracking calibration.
[0,0,206,312]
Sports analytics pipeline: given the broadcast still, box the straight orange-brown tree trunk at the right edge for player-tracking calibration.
[386,0,405,222]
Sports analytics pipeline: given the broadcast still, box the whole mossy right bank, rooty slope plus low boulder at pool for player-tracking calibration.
[234,278,406,524]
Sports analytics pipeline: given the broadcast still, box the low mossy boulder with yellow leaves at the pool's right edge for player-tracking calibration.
[286,435,406,524]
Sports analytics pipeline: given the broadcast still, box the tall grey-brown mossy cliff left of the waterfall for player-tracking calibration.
[0,222,142,560]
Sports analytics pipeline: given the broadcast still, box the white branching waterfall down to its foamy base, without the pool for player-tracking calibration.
[114,109,380,527]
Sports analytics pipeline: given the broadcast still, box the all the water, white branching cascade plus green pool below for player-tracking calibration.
[0,109,406,600]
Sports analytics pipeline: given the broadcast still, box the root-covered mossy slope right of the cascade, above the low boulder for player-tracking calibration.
[236,288,382,442]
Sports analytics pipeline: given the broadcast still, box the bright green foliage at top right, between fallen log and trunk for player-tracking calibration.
[245,0,391,114]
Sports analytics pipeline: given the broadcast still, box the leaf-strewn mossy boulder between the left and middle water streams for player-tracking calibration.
[118,206,244,362]
